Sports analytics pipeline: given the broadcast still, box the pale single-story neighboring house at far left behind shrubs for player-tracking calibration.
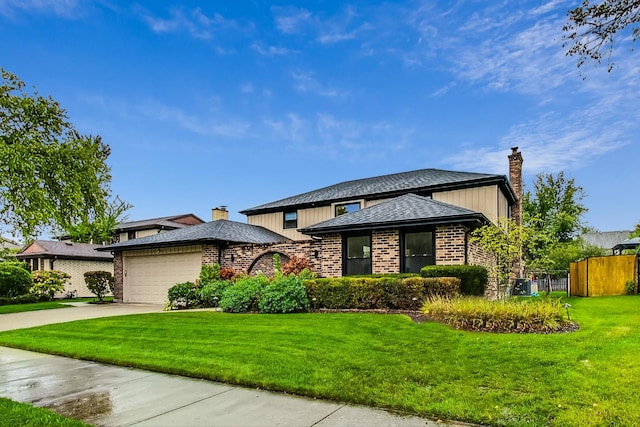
[16,240,113,297]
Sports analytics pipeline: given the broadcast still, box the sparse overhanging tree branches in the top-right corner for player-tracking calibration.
[563,0,640,71]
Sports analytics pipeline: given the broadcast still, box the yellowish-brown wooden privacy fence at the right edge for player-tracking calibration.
[569,255,638,297]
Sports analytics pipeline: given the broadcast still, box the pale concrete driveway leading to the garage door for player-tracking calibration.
[0,303,164,332]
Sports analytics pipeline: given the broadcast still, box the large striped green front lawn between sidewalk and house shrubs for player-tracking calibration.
[0,296,640,426]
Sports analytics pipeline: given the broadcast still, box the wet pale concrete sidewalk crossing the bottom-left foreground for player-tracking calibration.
[0,347,464,427]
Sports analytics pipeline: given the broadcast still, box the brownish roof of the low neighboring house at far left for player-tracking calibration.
[16,240,113,261]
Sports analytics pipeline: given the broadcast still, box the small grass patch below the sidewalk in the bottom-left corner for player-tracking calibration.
[0,397,87,427]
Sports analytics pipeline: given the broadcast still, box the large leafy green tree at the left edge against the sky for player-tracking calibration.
[0,69,111,238]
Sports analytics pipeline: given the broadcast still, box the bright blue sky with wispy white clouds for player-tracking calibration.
[0,0,640,236]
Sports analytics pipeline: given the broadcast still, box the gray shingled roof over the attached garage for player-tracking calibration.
[99,219,289,251]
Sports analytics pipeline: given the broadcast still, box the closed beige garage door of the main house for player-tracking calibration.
[123,251,202,304]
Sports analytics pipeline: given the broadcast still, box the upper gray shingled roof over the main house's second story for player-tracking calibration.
[240,169,516,215]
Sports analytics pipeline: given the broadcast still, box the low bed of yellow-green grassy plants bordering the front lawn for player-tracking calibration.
[422,297,567,333]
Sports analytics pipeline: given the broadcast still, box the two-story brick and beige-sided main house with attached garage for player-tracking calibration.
[98,147,522,303]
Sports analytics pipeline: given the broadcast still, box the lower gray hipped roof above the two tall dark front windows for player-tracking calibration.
[300,194,489,236]
